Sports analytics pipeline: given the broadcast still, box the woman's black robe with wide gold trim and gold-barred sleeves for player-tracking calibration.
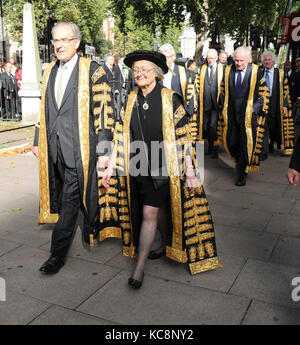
[99,88,220,274]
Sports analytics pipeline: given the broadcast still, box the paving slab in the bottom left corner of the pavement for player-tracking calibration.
[0,289,50,325]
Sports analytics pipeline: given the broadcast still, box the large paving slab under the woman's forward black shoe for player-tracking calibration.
[77,272,250,325]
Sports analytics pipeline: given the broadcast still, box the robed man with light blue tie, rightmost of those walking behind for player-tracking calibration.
[261,51,294,158]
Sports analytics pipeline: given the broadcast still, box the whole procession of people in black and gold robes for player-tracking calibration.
[33,22,300,289]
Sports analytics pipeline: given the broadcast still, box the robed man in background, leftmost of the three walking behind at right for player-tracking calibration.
[196,49,224,158]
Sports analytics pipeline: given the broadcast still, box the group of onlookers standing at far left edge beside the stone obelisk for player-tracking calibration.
[0,58,22,121]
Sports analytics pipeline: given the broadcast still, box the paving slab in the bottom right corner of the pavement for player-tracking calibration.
[242,301,300,326]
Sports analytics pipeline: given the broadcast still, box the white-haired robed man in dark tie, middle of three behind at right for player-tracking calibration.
[220,47,269,186]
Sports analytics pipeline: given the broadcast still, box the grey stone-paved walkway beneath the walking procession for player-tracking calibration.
[0,146,300,325]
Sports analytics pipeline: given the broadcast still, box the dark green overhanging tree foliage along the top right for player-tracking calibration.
[111,0,286,42]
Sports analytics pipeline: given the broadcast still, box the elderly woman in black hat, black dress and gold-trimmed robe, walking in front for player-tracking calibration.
[100,50,219,289]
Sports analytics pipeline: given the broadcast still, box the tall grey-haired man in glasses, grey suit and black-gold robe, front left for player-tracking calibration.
[33,22,114,273]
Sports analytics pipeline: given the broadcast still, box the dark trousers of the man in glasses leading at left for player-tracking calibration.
[51,140,90,257]
